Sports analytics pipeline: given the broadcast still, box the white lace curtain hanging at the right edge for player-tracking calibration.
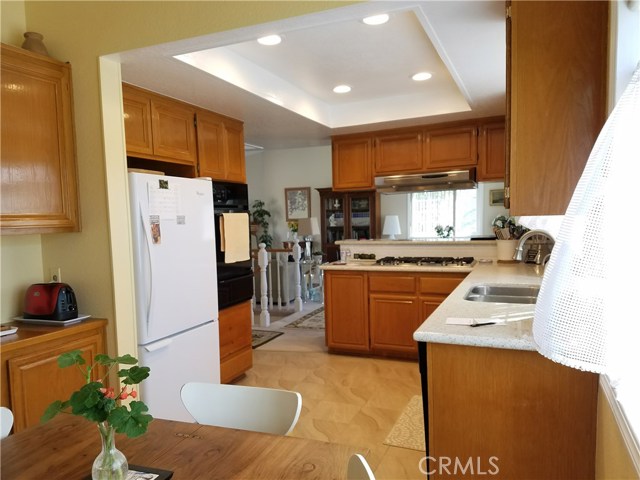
[533,66,640,381]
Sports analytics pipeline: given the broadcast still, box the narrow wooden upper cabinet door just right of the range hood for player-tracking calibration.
[477,122,506,182]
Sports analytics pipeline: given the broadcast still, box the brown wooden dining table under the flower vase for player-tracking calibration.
[0,414,368,480]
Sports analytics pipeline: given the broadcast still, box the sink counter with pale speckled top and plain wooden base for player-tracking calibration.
[413,264,598,479]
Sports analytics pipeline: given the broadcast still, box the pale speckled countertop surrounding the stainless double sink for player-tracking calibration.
[413,263,544,351]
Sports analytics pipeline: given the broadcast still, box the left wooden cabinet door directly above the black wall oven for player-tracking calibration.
[196,111,227,180]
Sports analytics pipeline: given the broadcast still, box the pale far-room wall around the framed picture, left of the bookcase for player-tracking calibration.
[246,145,331,248]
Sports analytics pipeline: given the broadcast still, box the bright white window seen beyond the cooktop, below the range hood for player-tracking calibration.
[409,189,478,238]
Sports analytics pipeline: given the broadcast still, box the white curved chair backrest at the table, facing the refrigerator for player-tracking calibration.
[180,382,302,435]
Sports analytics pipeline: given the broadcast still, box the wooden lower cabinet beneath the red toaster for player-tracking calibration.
[1,319,107,433]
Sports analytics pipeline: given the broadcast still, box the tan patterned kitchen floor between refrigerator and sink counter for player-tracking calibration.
[236,306,425,480]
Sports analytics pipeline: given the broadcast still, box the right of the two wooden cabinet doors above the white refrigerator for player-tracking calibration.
[151,97,197,165]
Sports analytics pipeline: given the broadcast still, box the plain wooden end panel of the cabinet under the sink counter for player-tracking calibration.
[421,343,598,480]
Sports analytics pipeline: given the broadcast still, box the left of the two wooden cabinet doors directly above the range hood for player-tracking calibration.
[374,131,424,175]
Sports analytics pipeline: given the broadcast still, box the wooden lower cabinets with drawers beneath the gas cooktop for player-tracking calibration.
[324,270,467,359]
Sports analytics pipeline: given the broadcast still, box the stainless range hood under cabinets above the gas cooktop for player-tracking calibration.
[375,168,477,194]
